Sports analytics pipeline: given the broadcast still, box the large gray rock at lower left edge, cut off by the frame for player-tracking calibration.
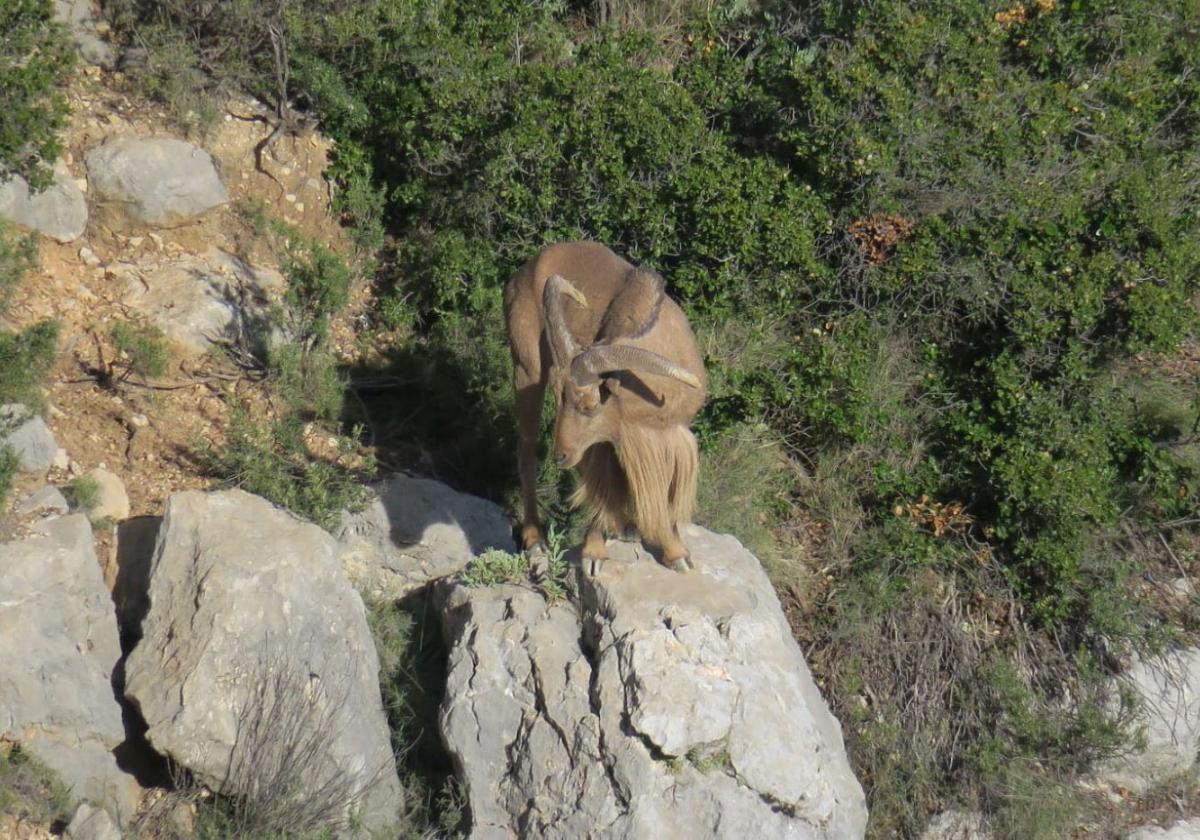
[0,516,139,822]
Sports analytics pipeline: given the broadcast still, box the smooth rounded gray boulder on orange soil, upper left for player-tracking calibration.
[86,137,229,227]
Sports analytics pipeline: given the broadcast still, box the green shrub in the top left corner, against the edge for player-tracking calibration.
[0,0,74,188]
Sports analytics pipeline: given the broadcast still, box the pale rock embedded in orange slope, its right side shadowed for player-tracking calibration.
[115,248,286,354]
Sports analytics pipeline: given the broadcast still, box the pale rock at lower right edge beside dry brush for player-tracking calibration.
[1097,648,1200,793]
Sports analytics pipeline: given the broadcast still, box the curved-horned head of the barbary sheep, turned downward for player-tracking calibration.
[542,275,700,468]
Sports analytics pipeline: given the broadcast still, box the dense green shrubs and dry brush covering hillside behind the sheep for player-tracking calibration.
[0,0,1200,838]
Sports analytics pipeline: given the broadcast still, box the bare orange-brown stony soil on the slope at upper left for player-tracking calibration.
[8,67,364,528]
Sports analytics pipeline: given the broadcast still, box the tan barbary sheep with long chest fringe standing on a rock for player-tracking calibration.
[504,242,708,574]
